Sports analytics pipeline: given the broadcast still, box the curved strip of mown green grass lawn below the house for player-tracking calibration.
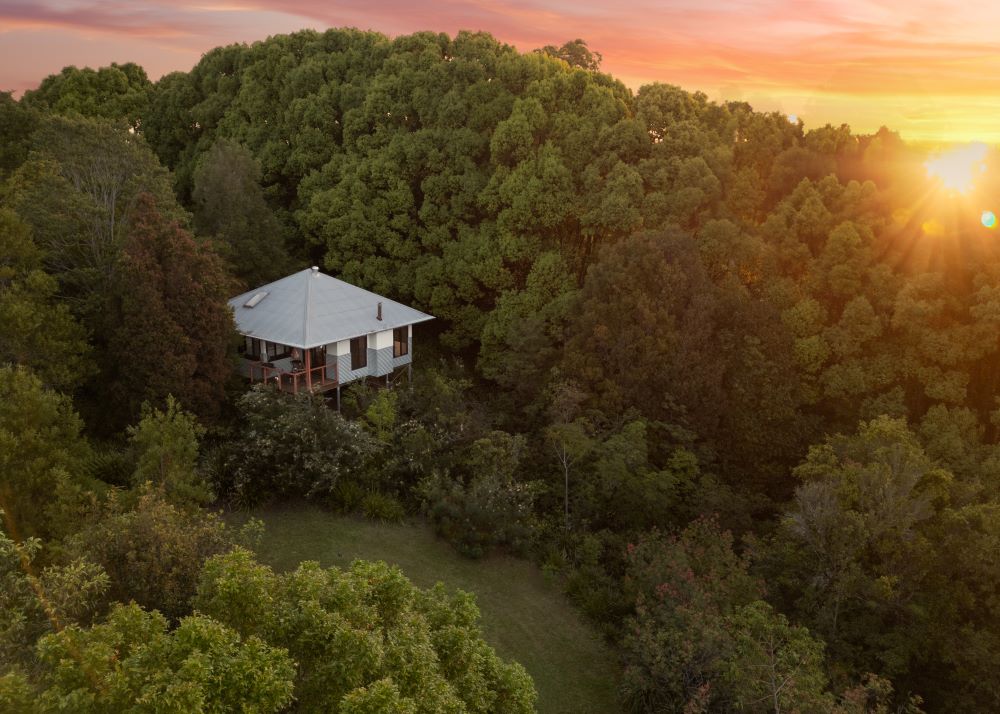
[237,505,619,714]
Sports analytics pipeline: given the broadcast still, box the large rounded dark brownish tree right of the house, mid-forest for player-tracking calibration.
[562,229,804,496]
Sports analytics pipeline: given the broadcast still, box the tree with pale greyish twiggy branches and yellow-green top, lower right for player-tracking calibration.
[772,417,951,659]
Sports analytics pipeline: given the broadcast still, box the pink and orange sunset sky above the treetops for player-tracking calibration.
[0,0,1000,143]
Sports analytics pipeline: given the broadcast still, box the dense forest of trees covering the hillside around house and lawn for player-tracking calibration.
[0,29,1000,714]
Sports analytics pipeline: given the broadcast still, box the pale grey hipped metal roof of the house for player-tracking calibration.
[229,268,434,349]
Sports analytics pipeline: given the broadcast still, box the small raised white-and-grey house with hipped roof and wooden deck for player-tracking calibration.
[229,267,434,404]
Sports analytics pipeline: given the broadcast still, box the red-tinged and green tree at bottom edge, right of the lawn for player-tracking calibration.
[622,519,852,714]
